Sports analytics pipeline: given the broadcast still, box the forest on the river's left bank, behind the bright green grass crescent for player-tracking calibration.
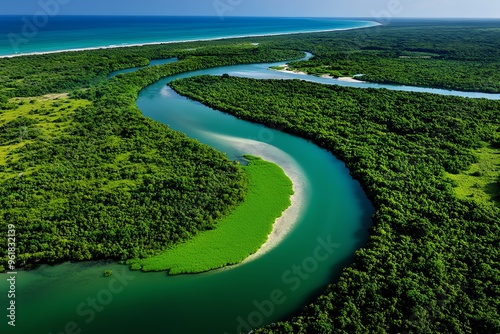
[0,42,302,266]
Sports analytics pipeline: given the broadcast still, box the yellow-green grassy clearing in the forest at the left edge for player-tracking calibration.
[0,94,90,180]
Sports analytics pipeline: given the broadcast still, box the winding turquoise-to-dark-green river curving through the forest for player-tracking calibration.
[0,54,500,334]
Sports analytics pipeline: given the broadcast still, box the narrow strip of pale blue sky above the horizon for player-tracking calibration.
[0,0,500,18]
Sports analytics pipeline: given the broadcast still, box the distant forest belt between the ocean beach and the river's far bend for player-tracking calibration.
[0,20,500,100]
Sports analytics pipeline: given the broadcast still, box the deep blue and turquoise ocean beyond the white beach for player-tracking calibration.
[0,15,376,56]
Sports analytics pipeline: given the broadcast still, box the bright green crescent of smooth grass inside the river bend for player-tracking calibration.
[133,156,293,275]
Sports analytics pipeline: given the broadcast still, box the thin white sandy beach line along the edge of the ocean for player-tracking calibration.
[0,21,382,58]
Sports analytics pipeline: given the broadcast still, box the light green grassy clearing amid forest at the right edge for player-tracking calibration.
[447,143,500,207]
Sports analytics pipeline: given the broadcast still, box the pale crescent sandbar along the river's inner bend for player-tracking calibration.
[207,133,308,264]
